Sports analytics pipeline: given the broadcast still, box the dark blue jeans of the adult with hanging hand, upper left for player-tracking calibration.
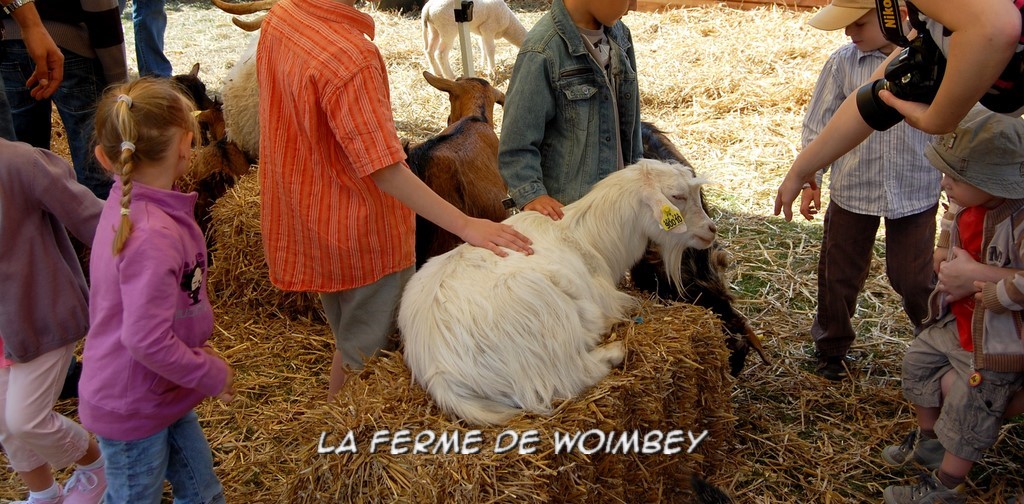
[0,40,113,200]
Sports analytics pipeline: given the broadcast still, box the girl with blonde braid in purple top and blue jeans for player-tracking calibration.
[79,78,233,504]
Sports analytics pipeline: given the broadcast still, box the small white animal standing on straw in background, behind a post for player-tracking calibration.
[420,0,526,79]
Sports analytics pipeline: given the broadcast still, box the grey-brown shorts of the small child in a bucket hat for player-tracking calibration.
[903,316,1024,462]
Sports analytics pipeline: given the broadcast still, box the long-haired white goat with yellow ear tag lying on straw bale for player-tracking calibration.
[398,160,716,424]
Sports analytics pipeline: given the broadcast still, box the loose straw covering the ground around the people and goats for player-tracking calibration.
[0,1,1024,504]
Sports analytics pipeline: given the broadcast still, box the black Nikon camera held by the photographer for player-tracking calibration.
[857,32,946,131]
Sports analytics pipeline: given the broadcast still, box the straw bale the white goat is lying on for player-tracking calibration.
[285,301,735,503]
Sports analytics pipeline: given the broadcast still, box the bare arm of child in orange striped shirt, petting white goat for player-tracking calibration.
[370,163,534,257]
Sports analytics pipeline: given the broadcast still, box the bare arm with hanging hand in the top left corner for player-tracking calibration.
[0,0,63,99]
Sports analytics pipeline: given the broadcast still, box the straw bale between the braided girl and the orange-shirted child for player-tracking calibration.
[210,169,323,320]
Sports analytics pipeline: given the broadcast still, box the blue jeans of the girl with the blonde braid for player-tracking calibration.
[96,411,224,504]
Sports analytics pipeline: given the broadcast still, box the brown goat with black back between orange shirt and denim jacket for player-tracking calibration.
[406,72,508,267]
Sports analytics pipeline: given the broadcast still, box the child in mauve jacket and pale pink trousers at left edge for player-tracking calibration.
[0,139,104,504]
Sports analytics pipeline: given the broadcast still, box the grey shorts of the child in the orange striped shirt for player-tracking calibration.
[319,266,415,370]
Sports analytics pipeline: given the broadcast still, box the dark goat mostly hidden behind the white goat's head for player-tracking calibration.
[630,122,769,376]
